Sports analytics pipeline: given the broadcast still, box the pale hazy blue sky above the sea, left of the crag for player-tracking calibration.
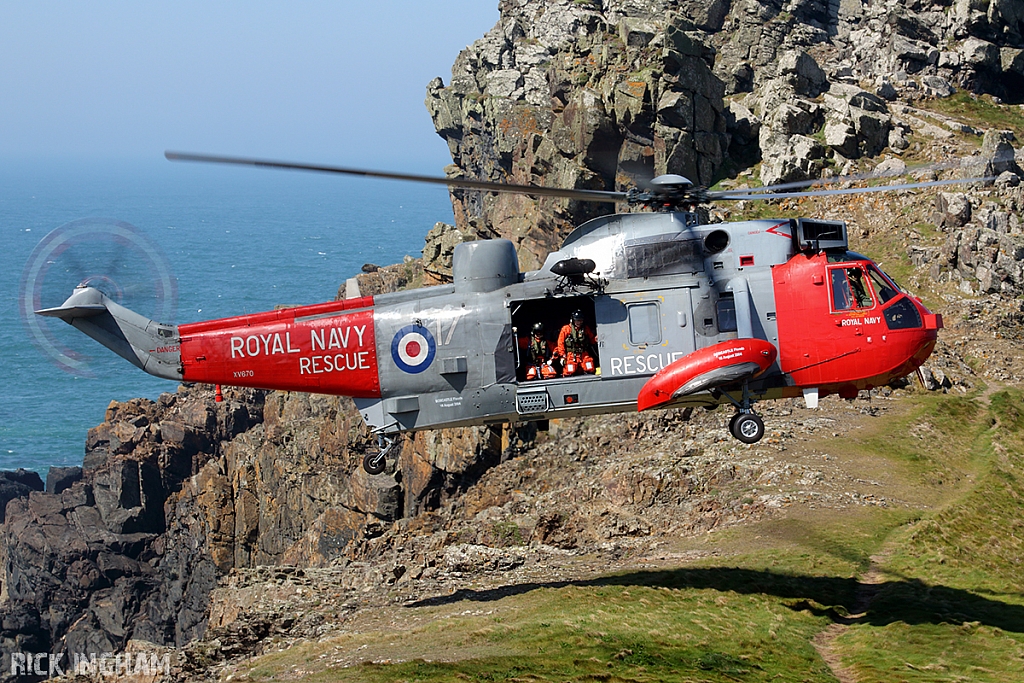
[0,0,498,172]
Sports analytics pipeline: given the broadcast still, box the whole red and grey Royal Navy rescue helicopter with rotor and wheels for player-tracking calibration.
[36,152,989,474]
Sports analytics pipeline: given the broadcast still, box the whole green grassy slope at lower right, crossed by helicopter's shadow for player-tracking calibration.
[230,390,1024,683]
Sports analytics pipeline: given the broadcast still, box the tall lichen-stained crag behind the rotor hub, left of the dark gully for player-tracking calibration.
[426,0,728,268]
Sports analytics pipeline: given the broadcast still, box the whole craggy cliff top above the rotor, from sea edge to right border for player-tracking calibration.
[426,0,1024,268]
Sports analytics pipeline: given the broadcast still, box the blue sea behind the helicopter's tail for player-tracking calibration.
[0,158,453,479]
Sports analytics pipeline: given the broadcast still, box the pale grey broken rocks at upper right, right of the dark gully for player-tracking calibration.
[701,0,1024,184]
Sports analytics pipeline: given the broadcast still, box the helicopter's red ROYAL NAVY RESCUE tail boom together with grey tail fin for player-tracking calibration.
[36,287,381,398]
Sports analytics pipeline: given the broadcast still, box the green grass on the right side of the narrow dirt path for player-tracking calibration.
[837,389,1024,682]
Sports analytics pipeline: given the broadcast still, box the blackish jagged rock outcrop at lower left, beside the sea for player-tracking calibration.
[0,390,262,667]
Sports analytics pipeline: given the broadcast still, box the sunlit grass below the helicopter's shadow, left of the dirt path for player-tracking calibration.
[262,581,833,683]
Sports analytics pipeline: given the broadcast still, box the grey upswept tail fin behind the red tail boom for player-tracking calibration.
[36,287,181,380]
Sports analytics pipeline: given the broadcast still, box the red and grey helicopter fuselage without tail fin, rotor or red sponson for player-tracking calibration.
[179,212,938,433]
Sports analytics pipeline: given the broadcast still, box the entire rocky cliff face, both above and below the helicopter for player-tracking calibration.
[6,0,1024,675]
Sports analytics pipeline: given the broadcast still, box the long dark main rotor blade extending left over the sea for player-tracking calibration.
[164,152,626,204]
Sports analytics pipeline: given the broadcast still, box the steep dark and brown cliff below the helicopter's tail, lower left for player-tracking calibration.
[0,374,500,673]
